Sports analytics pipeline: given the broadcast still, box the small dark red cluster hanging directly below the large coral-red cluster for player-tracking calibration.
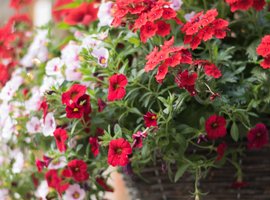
[175,70,198,96]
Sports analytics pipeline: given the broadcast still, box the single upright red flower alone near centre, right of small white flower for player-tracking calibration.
[108,74,128,101]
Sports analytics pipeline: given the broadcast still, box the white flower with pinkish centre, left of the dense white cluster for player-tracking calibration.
[45,57,64,77]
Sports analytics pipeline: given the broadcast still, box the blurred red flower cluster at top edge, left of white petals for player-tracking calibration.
[53,0,98,25]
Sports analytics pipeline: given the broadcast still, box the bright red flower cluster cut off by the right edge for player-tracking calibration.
[257,35,270,69]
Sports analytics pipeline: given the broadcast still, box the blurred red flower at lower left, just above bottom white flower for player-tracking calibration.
[45,169,69,194]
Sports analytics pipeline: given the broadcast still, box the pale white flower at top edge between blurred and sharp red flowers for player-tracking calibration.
[97,1,113,26]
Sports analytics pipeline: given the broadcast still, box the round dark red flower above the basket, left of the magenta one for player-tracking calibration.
[205,115,226,139]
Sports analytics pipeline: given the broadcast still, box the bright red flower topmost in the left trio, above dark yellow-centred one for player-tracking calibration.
[62,84,86,105]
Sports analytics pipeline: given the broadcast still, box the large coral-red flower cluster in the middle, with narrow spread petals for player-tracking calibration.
[144,37,192,83]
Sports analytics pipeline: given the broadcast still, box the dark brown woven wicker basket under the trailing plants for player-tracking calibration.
[125,147,270,200]
